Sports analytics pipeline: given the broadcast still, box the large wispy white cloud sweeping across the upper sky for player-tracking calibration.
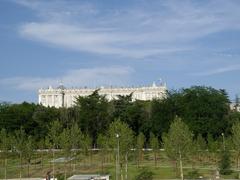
[17,0,240,58]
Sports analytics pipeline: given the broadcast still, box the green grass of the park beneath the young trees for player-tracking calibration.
[0,152,237,180]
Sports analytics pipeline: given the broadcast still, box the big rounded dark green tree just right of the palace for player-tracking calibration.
[178,86,230,139]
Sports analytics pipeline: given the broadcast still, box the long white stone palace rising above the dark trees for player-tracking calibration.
[38,83,167,108]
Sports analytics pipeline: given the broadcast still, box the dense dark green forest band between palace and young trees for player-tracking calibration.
[0,86,240,147]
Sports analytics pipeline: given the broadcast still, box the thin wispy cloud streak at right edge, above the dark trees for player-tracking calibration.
[191,64,240,76]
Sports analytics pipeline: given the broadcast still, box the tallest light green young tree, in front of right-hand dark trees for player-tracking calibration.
[163,117,192,180]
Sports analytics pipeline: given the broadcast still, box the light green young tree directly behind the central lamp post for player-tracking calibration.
[108,119,133,179]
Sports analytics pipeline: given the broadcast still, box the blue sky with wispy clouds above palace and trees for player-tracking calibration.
[0,0,240,102]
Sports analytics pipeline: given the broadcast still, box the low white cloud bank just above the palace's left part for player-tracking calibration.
[0,66,134,90]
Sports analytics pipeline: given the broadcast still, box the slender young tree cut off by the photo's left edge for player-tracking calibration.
[0,129,10,179]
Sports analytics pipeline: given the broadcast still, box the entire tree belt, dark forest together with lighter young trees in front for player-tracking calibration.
[0,86,240,179]
